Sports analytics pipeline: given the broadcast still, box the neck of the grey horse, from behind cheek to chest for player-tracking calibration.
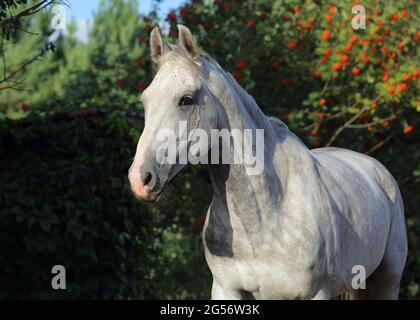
[205,68,314,241]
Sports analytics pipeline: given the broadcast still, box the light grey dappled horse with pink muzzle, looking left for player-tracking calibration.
[128,25,407,300]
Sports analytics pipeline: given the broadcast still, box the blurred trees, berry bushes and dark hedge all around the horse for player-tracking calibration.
[0,0,420,299]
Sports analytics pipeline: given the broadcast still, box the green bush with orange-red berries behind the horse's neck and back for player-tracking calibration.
[179,0,420,144]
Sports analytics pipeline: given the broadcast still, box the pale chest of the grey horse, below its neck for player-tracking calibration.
[203,195,324,299]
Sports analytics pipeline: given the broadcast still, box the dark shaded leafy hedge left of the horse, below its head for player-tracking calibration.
[0,116,211,299]
